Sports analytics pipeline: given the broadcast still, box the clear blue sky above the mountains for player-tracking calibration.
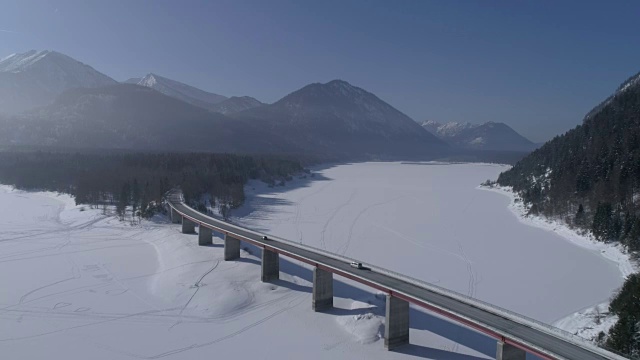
[0,0,640,141]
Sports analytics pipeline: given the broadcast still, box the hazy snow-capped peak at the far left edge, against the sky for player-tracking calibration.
[0,50,116,114]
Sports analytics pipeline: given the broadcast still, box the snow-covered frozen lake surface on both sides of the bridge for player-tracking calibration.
[0,163,622,360]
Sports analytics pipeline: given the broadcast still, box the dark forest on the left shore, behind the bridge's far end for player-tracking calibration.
[0,151,303,217]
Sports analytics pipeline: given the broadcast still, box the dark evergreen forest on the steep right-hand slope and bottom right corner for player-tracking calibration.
[497,74,640,356]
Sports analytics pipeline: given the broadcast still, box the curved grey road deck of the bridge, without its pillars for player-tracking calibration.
[167,192,625,360]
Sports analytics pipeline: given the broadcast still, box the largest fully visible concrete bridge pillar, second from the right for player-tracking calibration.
[384,295,409,350]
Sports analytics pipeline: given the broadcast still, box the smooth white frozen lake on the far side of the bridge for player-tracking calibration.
[236,163,623,323]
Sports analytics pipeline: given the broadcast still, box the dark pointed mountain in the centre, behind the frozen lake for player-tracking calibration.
[230,80,448,159]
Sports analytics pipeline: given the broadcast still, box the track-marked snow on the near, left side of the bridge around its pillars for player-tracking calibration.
[0,186,495,359]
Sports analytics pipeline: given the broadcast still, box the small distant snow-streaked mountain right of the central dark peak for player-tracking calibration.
[422,121,537,151]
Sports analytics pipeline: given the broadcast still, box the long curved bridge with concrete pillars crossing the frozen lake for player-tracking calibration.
[166,190,625,360]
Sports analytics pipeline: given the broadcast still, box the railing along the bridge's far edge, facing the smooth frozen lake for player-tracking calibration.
[166,194,628,360]
